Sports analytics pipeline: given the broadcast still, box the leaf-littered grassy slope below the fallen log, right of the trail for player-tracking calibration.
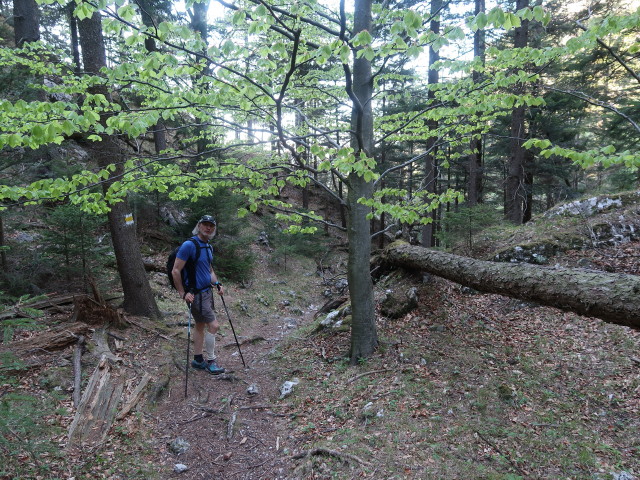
[279,276,640,480]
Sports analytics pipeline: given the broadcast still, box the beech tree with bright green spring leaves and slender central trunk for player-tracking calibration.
[0,0,637,363]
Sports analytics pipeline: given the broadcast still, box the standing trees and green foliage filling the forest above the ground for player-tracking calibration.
[0,0,640,476]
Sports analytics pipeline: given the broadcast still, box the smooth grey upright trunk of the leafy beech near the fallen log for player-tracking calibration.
[347,0,378,365]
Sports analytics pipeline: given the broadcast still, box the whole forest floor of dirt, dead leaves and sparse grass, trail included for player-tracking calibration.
[0,237,640,480]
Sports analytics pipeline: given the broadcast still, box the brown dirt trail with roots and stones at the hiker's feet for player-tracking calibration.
[152,288,320,480]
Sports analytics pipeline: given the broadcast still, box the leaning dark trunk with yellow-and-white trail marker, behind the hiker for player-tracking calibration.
[78,12,161,318]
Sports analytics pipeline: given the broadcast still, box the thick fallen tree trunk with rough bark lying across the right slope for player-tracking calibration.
[382,242,640,329]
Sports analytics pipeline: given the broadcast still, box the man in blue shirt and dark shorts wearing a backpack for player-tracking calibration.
[171,215,224,375]
